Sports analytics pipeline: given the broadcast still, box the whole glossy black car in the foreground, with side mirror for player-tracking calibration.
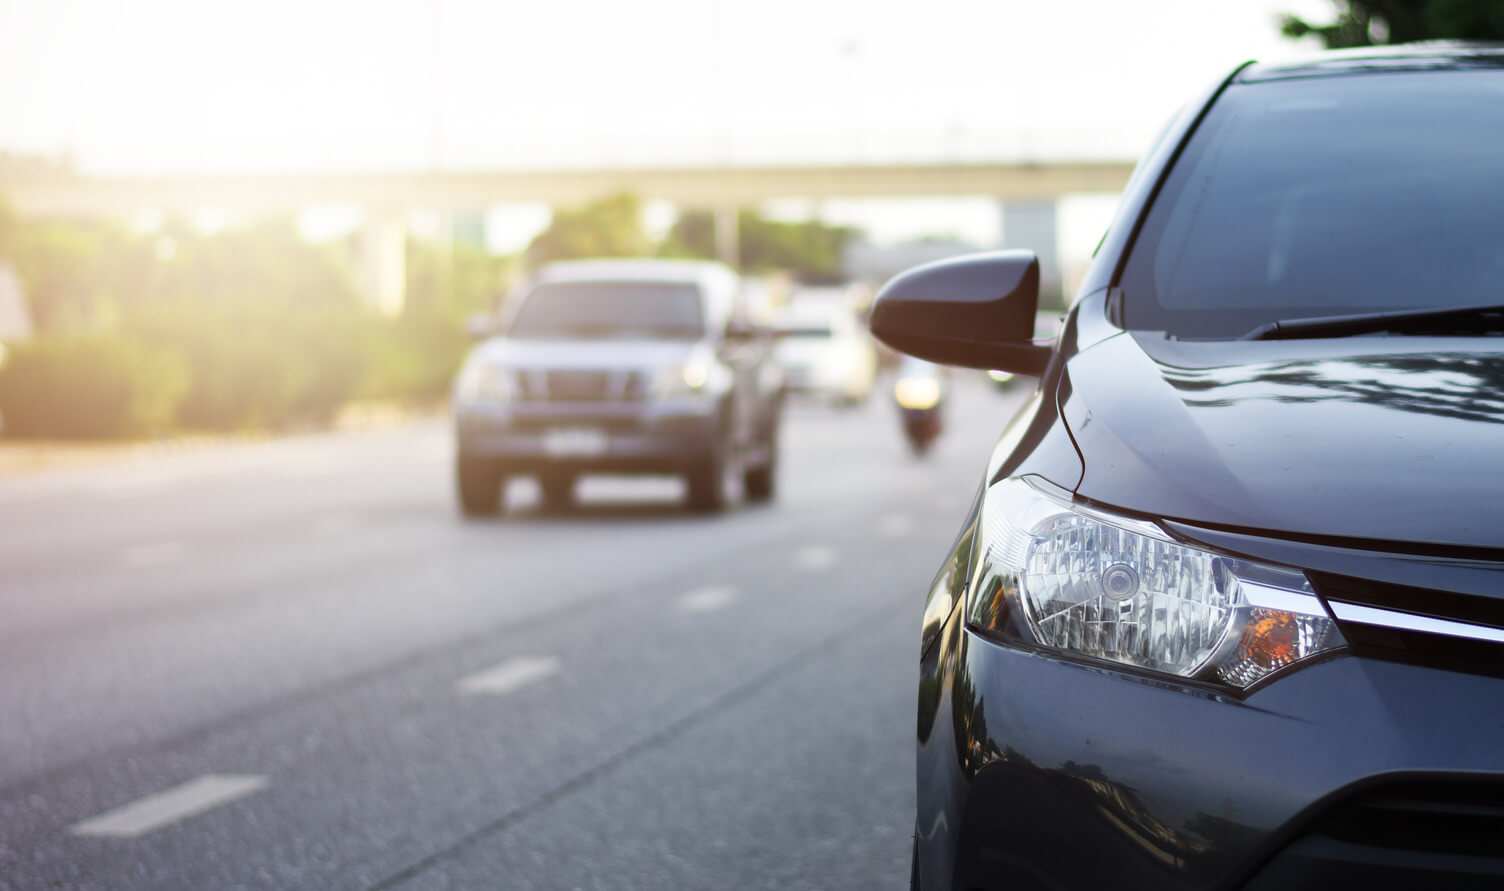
[871,45,1504,891]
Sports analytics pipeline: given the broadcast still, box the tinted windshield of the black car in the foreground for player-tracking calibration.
[1122,71,1504,339]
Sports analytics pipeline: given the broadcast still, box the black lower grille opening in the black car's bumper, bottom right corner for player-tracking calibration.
[1247,778,1504,889]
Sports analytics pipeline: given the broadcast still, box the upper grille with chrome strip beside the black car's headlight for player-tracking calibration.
[1307,572,1504,677]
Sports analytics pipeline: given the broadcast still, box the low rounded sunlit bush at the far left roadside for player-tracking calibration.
[0,336,188,438]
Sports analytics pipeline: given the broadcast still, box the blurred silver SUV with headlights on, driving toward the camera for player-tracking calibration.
[454,260,782,516]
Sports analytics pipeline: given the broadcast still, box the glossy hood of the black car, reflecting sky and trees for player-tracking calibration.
[1062,333,1504,548]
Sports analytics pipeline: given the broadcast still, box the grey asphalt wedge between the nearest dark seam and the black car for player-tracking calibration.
[394,591,917,891]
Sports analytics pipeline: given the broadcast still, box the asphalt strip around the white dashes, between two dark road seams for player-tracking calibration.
[0,436,974,888]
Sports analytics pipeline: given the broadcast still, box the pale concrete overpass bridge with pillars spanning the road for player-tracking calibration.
[0,160,1133,310]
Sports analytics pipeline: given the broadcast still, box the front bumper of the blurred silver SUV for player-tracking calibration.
[454,400,720,474]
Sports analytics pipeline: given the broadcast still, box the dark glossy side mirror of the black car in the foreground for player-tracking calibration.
[869,250,1053,376]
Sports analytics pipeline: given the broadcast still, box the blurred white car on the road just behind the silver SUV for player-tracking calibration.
[773,303,877,405]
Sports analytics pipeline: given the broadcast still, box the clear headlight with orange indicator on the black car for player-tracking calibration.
[967,479,1346,688]
